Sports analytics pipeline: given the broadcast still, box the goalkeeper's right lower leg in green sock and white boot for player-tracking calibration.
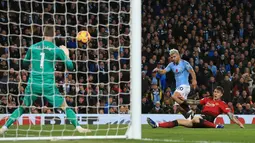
[61,100,91,133]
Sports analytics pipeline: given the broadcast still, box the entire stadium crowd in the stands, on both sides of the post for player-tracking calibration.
[0,0,255,114]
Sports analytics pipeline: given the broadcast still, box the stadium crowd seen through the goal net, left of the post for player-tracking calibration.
[0,0,130,114]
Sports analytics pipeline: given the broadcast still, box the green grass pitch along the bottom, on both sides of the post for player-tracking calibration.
[0,125,255,143]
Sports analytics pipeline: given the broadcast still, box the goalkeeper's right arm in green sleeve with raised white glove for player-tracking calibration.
[57,46,74,71]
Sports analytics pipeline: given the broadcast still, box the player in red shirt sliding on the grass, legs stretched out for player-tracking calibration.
[147,86,244,128]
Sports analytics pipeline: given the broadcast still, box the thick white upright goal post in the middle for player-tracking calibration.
[128,0,142,139]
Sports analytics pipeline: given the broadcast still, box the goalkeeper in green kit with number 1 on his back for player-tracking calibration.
[0,26,90,134]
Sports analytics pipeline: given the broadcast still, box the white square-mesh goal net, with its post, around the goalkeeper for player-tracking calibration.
[0,0,141,140]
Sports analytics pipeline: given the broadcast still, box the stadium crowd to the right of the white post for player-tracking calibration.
[142,0,255,114]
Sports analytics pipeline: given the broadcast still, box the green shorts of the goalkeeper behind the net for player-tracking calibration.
[23,83,64,108]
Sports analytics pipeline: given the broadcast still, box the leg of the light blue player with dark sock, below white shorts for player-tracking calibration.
[172,92,194,119]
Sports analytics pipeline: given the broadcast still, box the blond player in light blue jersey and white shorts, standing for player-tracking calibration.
[153,49,197,118]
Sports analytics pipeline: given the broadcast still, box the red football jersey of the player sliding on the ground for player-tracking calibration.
[200,98,231,117]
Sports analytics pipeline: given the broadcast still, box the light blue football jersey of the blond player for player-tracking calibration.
[165,60,193,88]
